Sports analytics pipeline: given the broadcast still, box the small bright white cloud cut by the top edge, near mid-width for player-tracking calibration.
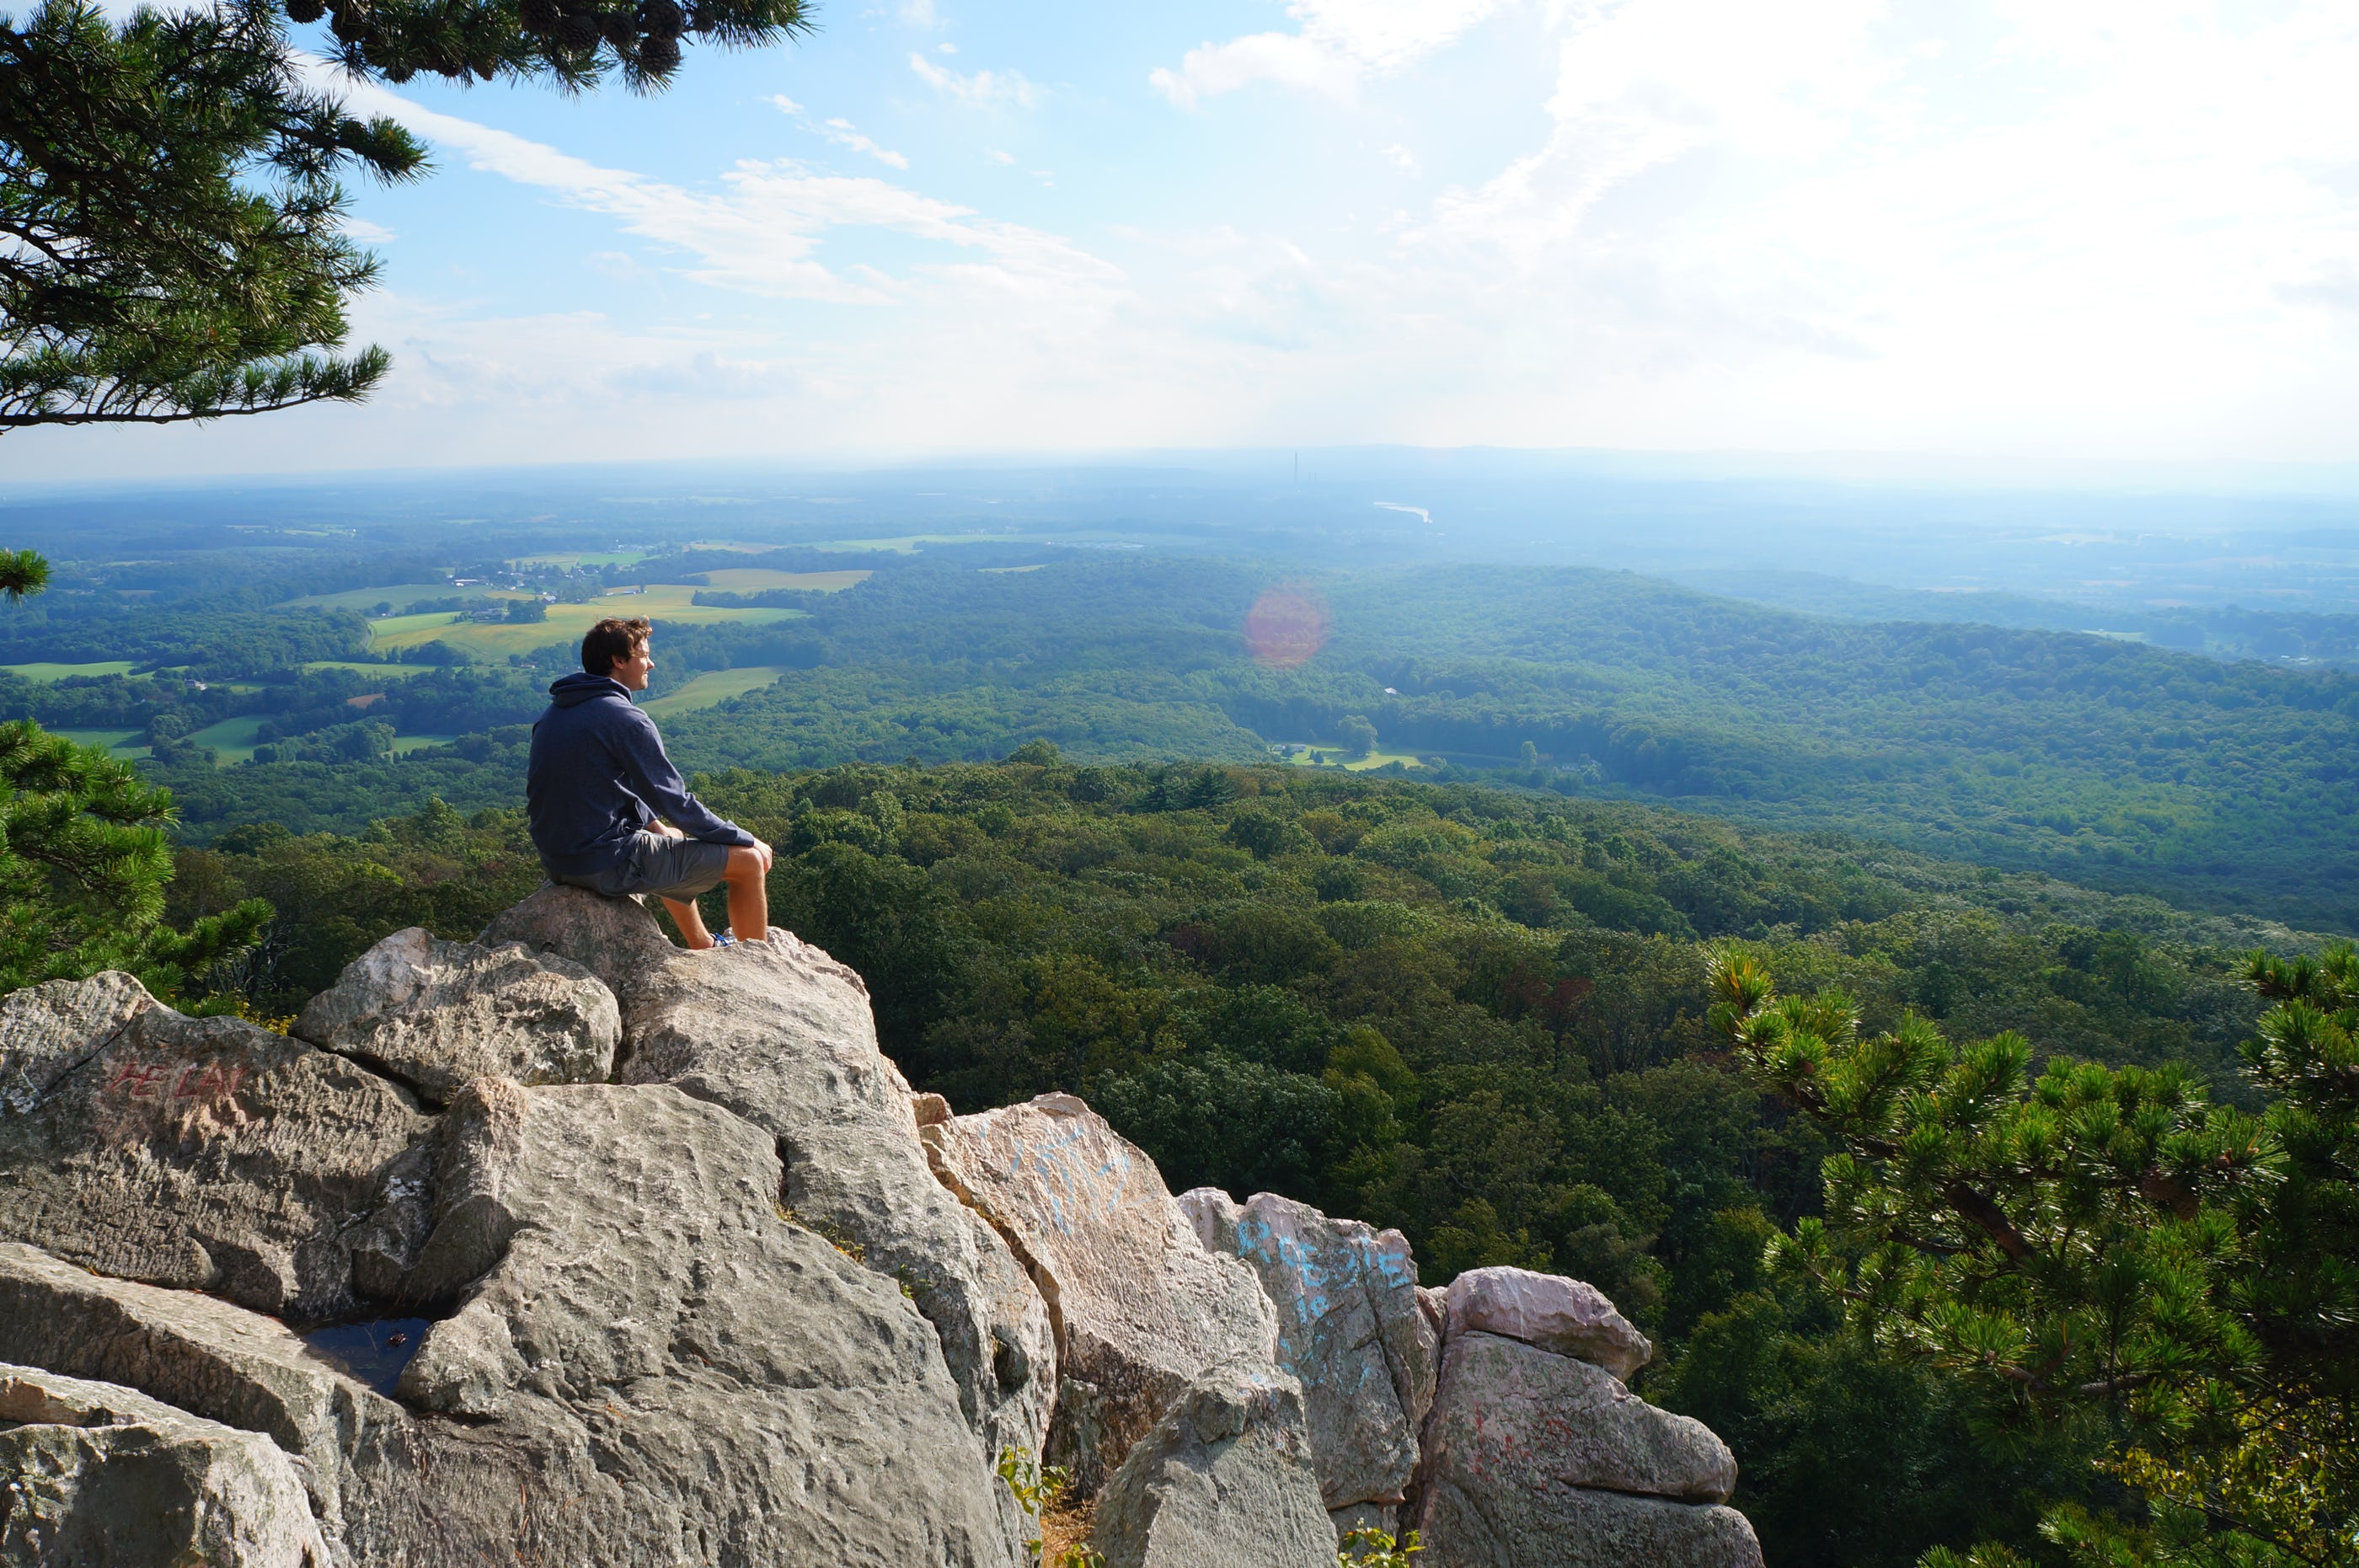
[1147,0,1500,109]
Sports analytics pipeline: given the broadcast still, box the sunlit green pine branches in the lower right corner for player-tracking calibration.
[1710,943,2359,1568]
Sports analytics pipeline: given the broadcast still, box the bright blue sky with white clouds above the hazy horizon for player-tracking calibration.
[5,0,2359,479]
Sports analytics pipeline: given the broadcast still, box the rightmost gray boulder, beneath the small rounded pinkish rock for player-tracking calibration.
[1410,1332,1763,1568]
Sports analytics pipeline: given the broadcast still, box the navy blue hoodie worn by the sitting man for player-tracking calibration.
[524,674,752,877]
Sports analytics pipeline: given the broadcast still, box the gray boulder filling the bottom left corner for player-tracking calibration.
[0,1363,333,1568]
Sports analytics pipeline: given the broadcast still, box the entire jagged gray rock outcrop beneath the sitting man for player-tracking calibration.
[0,889,1760,1568]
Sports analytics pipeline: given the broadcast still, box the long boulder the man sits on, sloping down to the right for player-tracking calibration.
[481,886,1056,1459]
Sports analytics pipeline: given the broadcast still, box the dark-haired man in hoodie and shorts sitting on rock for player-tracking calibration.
[524,618,769,948]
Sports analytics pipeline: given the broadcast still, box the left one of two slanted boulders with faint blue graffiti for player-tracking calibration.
[923,1094,1276,1497]
